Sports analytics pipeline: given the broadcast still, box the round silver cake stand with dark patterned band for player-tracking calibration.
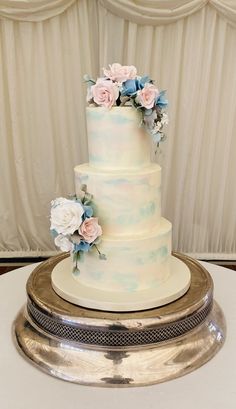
[14,253,226,387]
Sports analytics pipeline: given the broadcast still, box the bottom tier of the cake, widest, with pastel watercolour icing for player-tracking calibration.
[71,218,172,293]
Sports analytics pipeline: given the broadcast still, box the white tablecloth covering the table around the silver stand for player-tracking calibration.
[0,263,236,409]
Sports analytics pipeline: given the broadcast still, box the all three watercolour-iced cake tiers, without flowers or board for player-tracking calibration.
[71,107,172,294]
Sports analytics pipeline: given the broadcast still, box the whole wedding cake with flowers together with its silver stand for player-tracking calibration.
[14,64,225,387]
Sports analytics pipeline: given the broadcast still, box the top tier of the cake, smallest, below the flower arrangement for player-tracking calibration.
[86,106,150,170]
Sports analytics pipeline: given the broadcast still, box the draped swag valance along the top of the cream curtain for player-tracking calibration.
[0,0,236,25]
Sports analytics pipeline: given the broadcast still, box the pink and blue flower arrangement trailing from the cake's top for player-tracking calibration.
[84,63,168,146]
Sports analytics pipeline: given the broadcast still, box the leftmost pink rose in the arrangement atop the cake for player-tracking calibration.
[91,78,119,109]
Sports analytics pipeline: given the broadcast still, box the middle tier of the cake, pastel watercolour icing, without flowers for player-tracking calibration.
[75,163,161,236]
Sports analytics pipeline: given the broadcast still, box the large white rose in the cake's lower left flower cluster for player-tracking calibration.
[50,199,84,236]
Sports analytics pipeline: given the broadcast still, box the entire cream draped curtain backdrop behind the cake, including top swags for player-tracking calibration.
[0,0,236,259]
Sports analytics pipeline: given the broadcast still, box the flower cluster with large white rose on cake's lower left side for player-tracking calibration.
[50,185,106,274]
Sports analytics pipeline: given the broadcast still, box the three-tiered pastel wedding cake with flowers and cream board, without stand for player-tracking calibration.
[51,64,190,311]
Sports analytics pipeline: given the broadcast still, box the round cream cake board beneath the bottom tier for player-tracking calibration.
[51,252,191,312]
